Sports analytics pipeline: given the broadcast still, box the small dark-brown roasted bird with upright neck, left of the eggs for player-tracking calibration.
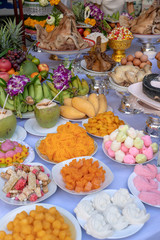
[84,36,116,72]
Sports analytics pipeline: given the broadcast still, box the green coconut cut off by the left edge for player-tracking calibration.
[0,109,17,140]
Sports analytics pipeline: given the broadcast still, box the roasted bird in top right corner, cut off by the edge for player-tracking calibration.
[119,5,160,34]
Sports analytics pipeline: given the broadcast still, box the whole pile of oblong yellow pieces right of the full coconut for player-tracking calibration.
[60,93,107,120]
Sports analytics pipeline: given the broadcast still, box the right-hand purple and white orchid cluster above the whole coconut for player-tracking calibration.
[52,64,72,90]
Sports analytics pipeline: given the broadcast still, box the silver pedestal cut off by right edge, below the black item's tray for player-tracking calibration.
[144,116,160,138]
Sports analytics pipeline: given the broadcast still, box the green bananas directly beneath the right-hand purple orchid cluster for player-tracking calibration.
[47,75,89,103]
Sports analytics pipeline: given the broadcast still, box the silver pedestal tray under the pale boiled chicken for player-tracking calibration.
[109,77,141,114]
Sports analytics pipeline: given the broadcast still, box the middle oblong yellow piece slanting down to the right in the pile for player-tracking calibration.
[72,97,96,117]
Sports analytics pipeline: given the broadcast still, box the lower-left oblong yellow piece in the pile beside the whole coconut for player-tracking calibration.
[60,106,85,119]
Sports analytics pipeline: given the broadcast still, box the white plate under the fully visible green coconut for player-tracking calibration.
[24,118,68,137]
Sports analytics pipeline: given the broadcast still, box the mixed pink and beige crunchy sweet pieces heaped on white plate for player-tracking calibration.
[1,164,51,202]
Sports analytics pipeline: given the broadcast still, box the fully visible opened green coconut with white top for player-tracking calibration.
[34,99,60,128]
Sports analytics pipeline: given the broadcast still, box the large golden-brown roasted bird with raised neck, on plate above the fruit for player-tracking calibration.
[35,2,88,51]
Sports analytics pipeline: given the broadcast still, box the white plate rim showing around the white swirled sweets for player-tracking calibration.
[76,189,146,239]
